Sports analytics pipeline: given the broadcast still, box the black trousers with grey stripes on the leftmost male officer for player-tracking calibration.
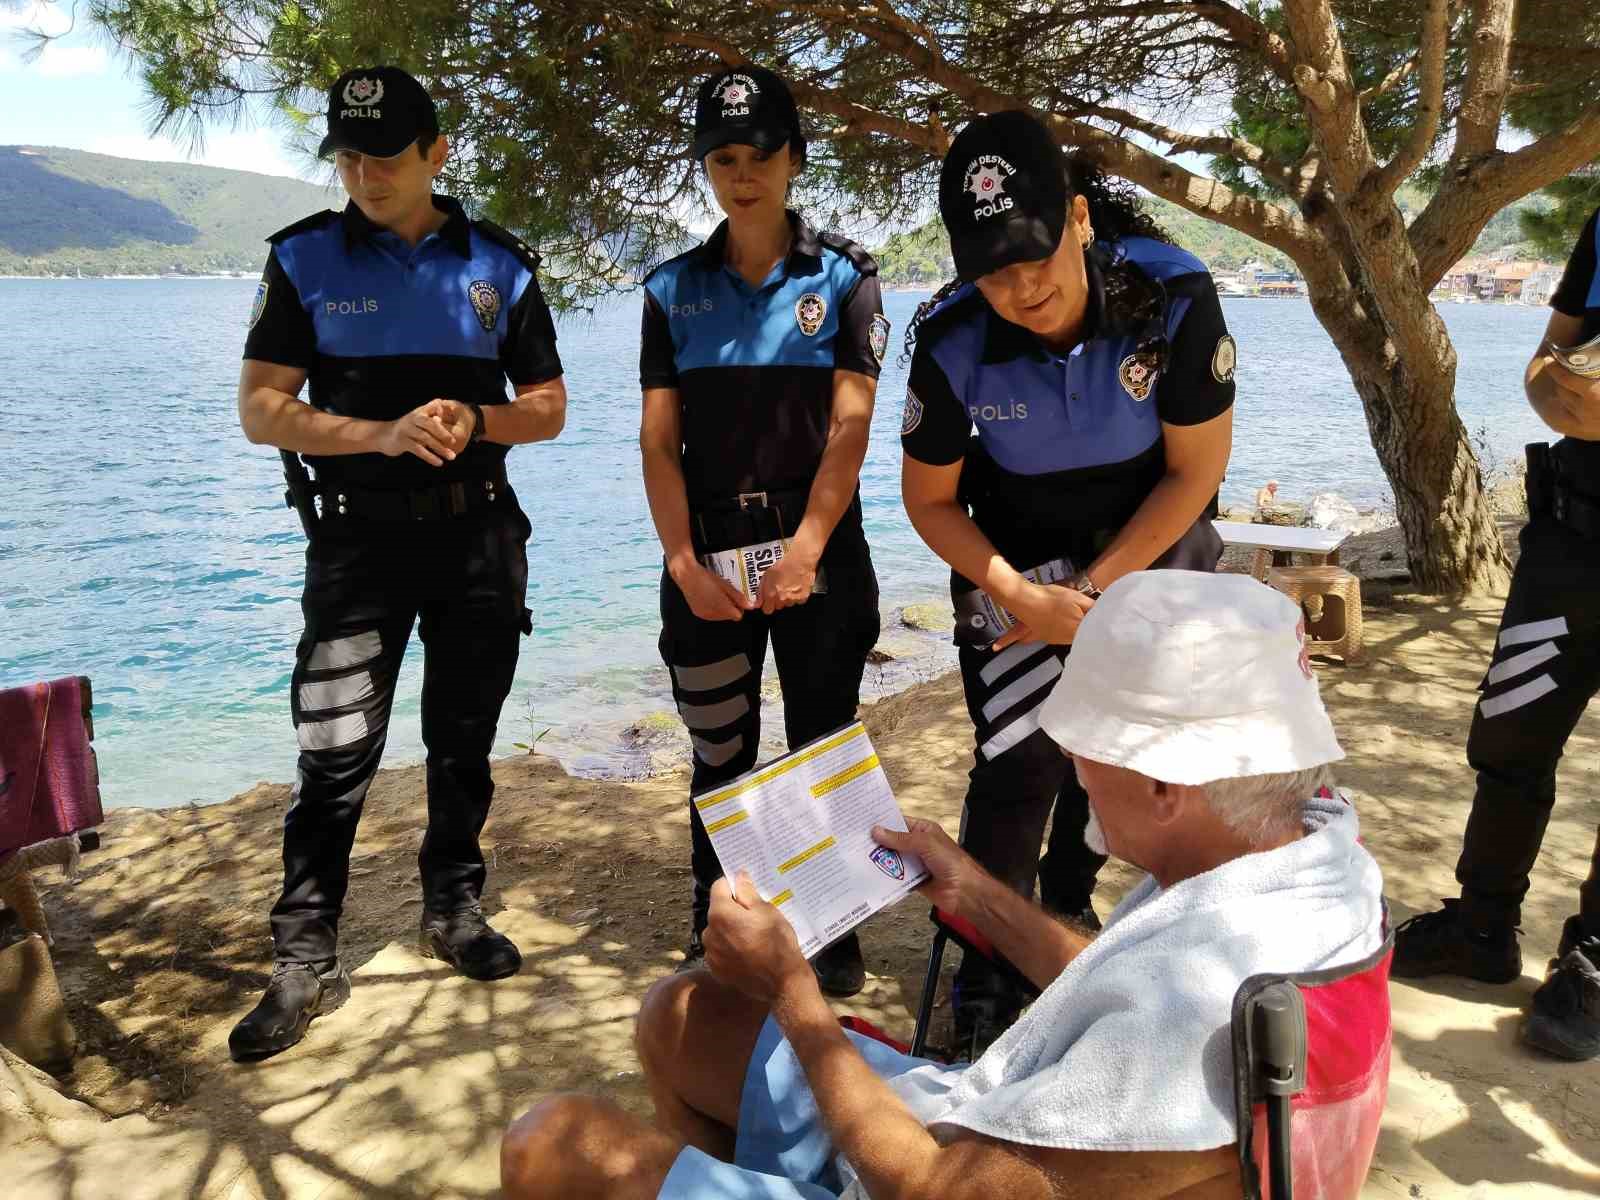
[272,494,530,962]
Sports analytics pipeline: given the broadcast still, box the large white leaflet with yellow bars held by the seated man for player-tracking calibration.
[693,722,928,958]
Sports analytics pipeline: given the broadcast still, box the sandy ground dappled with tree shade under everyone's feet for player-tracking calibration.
[0,528,1600,1200]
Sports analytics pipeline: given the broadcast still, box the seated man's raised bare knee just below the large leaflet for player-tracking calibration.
[634,970,766,1162]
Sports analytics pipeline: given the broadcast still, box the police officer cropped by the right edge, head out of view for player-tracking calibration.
[1392,213,1600,1059]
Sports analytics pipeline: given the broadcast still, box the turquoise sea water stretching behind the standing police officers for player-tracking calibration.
[0,280,1546,805]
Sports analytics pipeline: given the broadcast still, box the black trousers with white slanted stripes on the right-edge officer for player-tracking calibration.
[1456,515,1600,933]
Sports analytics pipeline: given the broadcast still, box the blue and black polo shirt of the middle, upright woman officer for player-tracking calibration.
[638,213,890,562]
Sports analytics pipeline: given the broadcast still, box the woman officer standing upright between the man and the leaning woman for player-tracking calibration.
[640,66,888,995]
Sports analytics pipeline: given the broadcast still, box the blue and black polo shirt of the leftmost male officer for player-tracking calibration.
[245,195,562,490]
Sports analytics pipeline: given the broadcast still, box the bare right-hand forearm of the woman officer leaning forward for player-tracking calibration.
[1088,408,1234,589]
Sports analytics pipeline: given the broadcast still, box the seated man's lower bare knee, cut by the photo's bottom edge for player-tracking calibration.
[501,1094,683,1200]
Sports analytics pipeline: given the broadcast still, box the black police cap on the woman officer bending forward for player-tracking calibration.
[939,112,1067,280]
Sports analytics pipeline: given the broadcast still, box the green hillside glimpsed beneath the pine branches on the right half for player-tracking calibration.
[872,189,1547,288]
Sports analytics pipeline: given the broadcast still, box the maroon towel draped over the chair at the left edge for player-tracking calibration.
[0,675,104,854]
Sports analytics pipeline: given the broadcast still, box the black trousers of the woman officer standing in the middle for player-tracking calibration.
[661,560,878,933]
